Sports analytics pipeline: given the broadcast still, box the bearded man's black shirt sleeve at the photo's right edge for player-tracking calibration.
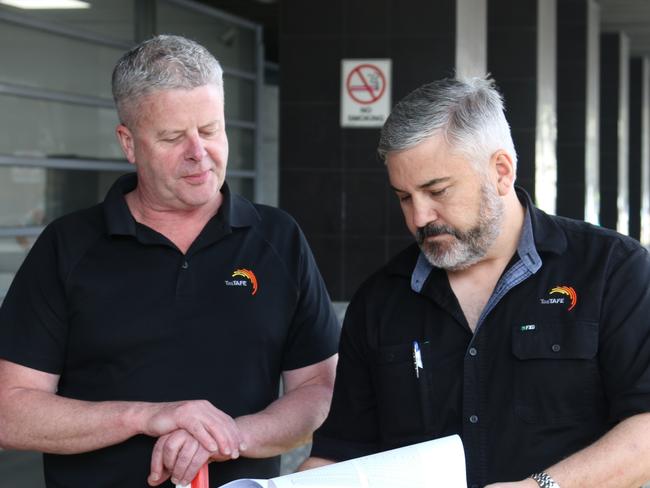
[599,247,650,422]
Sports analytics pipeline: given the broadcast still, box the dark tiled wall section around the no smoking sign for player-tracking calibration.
[279,0,456,300]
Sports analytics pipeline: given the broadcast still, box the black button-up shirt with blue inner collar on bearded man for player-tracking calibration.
[312,186,650,487]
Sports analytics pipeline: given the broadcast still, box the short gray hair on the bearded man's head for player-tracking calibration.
[377,76,517,172]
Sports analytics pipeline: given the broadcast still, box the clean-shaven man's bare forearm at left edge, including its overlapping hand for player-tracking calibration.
[0,388,243,457]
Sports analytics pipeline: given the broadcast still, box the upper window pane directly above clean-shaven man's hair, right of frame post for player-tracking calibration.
[156,0,256,73]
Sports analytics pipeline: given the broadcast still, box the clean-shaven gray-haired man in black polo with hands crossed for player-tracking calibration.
[0,36,339,488]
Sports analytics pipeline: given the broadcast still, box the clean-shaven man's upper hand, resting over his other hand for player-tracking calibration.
[142,400,246,458]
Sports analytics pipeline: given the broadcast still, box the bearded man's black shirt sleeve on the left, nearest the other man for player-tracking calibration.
[311,288,379,461]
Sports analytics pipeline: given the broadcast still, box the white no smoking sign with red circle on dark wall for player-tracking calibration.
[341,59,391,127]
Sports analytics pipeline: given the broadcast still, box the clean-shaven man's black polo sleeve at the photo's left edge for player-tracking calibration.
[0,225,68,374]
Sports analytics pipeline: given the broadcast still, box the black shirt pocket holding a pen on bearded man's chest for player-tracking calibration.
[375,342,433,440]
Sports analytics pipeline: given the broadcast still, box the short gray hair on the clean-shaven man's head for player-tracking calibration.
[112,35,223,123]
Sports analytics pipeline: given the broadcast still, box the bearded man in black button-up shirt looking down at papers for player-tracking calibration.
[303,78,650,488]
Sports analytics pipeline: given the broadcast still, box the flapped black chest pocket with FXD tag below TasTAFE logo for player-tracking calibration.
[512,321,604,424]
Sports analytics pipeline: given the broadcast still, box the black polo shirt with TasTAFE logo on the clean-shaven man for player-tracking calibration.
[0,174,339,488]
